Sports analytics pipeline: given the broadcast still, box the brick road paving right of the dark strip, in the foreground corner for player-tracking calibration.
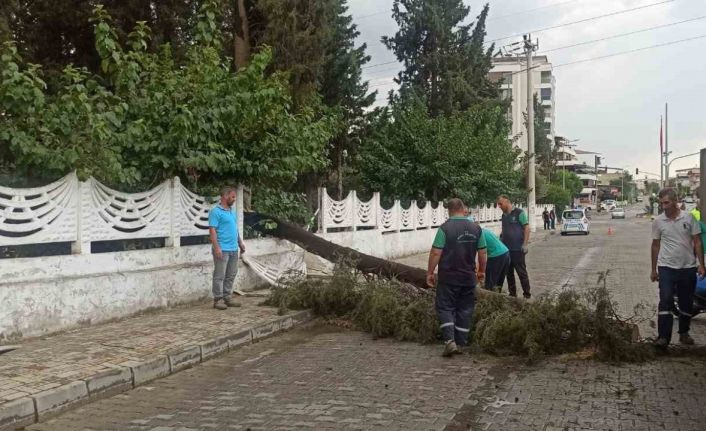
[473,358,706,431]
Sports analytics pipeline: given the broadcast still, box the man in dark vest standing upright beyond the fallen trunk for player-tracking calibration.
[497,195,532,298]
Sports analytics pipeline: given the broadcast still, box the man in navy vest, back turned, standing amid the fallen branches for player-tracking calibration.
[427,199,487,356]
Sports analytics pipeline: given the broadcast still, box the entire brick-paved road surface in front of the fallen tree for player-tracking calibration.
[27,326,706,431]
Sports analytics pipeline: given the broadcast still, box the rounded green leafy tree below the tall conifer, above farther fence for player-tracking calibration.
[361,99,521,204]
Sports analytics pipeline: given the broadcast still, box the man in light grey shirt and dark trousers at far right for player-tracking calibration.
[650,188,704,349]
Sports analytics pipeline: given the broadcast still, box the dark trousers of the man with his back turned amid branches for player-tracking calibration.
[436,283,476,346]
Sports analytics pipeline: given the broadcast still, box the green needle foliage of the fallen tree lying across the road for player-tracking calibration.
[266,265,653,362]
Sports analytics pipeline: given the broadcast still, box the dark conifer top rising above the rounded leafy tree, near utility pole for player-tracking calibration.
[382,0,497,117]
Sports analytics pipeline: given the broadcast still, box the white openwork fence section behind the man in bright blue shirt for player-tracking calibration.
[0,173,242,254]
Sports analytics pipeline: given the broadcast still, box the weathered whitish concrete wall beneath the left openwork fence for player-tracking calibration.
[0,239,304,342]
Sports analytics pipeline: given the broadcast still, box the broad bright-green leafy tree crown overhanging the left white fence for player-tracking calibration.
[0,5,334,192]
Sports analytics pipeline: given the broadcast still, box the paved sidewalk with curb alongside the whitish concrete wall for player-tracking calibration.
[0,298,310,431]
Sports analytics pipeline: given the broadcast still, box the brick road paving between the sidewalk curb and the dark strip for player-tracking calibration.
[27,326,494,431]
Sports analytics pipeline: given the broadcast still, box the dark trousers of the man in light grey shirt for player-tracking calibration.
[657,266,696,341]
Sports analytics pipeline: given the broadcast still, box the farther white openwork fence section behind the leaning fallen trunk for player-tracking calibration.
[319,188,553,233]
